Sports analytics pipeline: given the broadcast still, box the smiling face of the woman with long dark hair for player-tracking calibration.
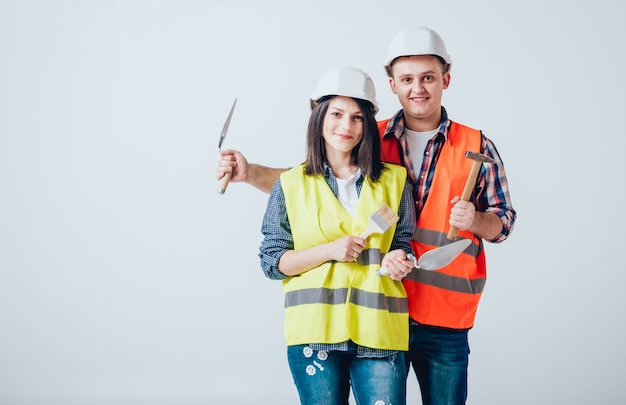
[323,96,363,154]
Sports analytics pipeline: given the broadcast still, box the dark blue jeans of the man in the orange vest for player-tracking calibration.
[407,324,470,405]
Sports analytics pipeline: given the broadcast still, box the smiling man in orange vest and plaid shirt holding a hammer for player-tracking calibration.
[216,27,516,405]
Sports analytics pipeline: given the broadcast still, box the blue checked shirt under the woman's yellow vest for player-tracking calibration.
[259,165,416,357]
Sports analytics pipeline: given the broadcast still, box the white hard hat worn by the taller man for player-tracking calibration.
[385,27,452,67]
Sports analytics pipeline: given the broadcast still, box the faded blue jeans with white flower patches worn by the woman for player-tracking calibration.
[287,345,407,405]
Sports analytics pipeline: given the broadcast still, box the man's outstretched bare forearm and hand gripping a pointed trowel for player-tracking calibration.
[215,149,287,194]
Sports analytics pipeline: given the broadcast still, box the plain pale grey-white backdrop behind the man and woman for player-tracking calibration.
[0,0,626,405]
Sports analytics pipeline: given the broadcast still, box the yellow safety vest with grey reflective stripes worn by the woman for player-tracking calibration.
[280,165,408,350]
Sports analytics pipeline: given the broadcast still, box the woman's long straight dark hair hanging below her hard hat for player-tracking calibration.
[305,96,384,182]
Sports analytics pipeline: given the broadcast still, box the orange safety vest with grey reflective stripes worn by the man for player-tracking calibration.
[378,120,487,329]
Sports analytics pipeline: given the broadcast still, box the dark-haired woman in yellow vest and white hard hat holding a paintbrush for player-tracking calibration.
[259,67,415,405]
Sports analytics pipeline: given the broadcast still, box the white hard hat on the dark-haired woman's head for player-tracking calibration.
[311,66,378,114]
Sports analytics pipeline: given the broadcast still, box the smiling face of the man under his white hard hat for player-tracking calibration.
[389,55,450,131]
